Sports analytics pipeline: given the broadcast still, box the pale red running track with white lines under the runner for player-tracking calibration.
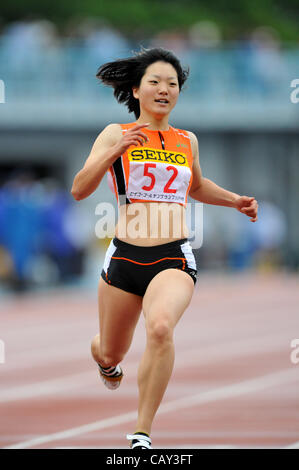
[0,274,299,449]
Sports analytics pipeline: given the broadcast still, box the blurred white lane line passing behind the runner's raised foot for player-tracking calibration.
[0,330,290,403]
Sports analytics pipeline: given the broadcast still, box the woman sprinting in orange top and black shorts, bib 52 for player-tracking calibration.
[72,48,258,449]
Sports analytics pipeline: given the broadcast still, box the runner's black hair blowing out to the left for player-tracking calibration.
[96,48,189,119]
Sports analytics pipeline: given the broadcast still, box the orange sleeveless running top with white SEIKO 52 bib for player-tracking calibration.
[108,122,193,206]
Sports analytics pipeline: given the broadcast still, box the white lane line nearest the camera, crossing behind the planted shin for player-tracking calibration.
[4,368,298,449]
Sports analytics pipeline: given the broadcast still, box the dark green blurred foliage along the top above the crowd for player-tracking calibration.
[1,0,299,41]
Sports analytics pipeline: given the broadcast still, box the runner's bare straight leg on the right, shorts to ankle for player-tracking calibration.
[136,269,194,434]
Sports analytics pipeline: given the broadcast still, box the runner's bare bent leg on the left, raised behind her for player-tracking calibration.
[91,278,142,367]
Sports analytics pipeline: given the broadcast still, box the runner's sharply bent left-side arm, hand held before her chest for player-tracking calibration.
[71,124,147,201]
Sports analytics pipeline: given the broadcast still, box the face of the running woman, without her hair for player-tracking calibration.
[133,61,180,116]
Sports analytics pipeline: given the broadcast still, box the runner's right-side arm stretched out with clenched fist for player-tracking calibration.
[189,132,258,222]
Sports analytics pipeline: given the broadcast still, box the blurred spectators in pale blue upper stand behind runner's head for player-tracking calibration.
[0,18,298,98]
